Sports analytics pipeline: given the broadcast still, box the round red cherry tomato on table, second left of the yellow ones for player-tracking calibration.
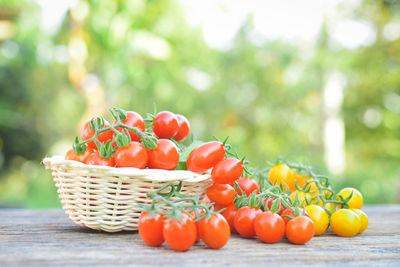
[254,211,286,244]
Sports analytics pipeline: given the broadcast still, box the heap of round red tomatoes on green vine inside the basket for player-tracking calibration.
[65,108,190,170]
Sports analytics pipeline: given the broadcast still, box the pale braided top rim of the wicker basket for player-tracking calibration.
[42,155,211,182]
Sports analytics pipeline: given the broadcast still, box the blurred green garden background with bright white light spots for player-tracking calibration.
[0,0,400,208]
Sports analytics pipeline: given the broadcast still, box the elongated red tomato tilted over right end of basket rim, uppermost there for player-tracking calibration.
[186,141,225,172]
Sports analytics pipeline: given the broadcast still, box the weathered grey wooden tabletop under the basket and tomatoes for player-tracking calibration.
[0,205,400,266]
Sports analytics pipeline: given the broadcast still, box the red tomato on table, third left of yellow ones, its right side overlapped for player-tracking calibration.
[234,206,261,237]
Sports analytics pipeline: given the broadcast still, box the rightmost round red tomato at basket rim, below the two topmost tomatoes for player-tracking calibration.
[147,139,179,170]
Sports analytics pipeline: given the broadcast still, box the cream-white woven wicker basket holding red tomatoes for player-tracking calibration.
[43,156,212,232]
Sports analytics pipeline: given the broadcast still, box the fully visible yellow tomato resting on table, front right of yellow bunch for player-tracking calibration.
[330,209,361,237]
